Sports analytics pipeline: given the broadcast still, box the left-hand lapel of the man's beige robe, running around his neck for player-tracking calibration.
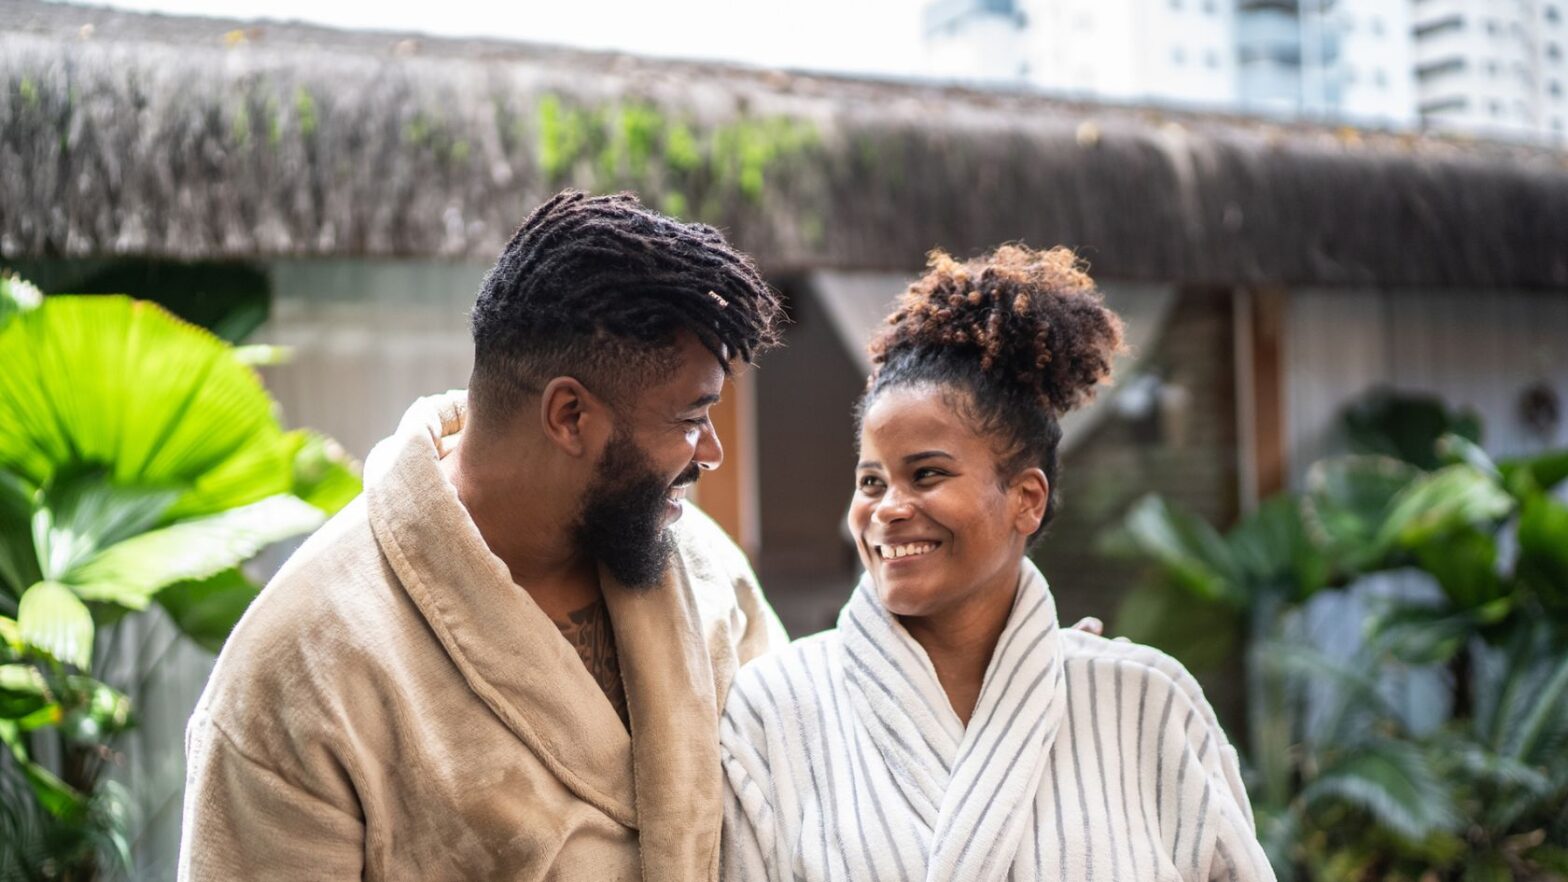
[365,392,639,829]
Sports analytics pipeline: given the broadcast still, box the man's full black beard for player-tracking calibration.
[577,433,699,590]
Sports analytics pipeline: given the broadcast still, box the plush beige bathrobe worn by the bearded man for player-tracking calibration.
[179,394,784,882]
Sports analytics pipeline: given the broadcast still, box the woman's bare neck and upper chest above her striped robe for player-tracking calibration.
[898,570,1018,727]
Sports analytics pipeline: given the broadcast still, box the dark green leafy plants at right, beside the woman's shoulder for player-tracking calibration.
[1107,394,1568,880]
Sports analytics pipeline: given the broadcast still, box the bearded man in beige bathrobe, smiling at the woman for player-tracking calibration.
[180,191,784,882]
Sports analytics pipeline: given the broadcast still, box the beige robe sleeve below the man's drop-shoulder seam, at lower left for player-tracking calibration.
[179,716,365,882]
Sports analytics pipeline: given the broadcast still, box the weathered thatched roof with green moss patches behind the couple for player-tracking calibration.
[0,0,1568,289]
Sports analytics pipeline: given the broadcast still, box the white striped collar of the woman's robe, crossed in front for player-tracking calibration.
[839,559,1066,880]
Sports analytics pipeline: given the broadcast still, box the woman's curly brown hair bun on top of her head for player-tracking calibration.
[870,245,1123,414]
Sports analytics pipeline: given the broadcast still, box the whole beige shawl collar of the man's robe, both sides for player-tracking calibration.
[365,392,721,882]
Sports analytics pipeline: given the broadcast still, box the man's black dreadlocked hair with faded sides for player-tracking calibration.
[470,190,781,413]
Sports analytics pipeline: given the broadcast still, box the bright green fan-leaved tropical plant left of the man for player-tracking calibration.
[0,271,359,879]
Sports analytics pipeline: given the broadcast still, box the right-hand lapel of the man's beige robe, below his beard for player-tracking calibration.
[599,546,723,882]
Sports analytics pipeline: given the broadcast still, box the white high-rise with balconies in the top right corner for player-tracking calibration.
[1411,0,1568,143]
